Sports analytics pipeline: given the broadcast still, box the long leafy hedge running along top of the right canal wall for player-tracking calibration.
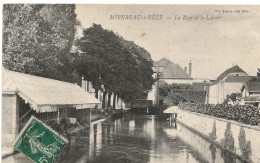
[179,103,260,125]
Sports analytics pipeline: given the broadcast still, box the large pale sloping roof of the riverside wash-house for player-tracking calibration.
[2,69,101,112]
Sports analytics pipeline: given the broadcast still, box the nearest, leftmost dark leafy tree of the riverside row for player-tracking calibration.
[76,24,126,96]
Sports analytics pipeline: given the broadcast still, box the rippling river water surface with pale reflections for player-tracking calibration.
[64,114,238,163]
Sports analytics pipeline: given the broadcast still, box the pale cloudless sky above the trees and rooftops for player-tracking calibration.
[76,4,260,79]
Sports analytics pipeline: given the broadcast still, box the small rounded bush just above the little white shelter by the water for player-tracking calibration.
[163,93,187,106]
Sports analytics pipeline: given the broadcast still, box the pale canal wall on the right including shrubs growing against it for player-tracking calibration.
[177,109,260,162]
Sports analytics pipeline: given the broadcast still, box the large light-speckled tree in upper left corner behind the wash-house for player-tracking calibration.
[3,4,77,79]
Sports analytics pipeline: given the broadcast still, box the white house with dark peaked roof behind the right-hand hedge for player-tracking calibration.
[206,65,252,104]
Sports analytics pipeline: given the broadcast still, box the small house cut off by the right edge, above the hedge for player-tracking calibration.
[240,82,260,107]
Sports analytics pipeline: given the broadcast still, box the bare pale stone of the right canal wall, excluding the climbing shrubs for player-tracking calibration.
[177,109,260,162]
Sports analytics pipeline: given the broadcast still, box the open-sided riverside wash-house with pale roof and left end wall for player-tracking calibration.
[2,69,101,150]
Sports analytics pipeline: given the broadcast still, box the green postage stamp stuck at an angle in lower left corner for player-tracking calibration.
[14,116,68,163]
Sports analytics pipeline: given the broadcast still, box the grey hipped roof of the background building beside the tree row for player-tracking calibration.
[160,63,192,79]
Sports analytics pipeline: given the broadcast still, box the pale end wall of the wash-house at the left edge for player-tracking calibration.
[2,94,19,147]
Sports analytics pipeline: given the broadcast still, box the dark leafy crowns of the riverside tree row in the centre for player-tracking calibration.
[76,24,154,101]
